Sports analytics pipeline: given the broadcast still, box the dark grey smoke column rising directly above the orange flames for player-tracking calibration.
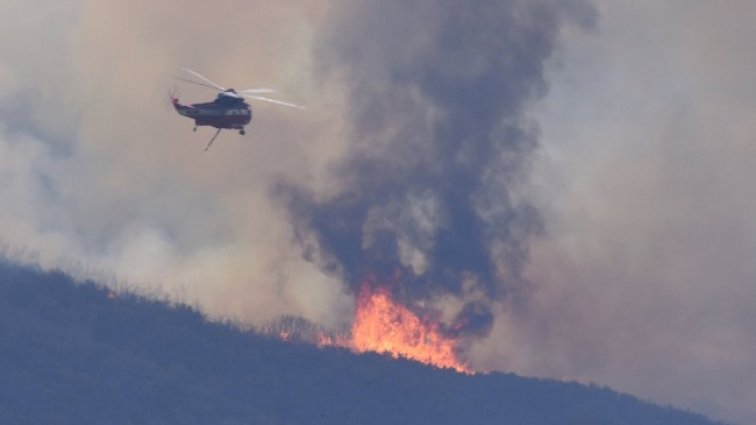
[276,0,591,335]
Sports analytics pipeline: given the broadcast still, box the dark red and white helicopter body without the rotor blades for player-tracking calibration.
[172,92,252,132]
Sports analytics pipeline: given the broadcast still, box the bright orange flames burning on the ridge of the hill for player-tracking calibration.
[349,285,471,373]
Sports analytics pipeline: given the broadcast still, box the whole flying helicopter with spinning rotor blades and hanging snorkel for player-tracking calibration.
[170,68,304,151]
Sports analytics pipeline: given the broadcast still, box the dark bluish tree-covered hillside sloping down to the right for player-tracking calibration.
[0,260,728,425]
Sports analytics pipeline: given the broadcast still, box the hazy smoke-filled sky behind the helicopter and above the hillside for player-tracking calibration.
[0,0,756,424]
